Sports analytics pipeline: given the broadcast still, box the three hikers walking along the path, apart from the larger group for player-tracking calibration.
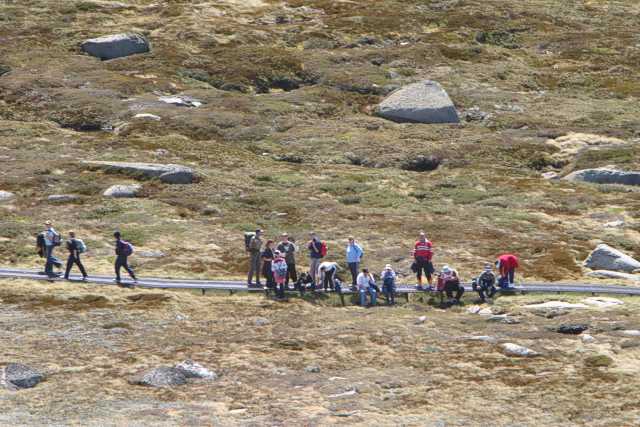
[36,221,138,287]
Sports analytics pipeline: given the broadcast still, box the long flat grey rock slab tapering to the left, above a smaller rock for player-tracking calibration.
[82,161,195,184]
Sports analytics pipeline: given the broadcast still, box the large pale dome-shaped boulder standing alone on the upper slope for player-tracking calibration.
[378,80,460,123]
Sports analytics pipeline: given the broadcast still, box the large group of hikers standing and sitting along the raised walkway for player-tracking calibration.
[245,229,519,306]
